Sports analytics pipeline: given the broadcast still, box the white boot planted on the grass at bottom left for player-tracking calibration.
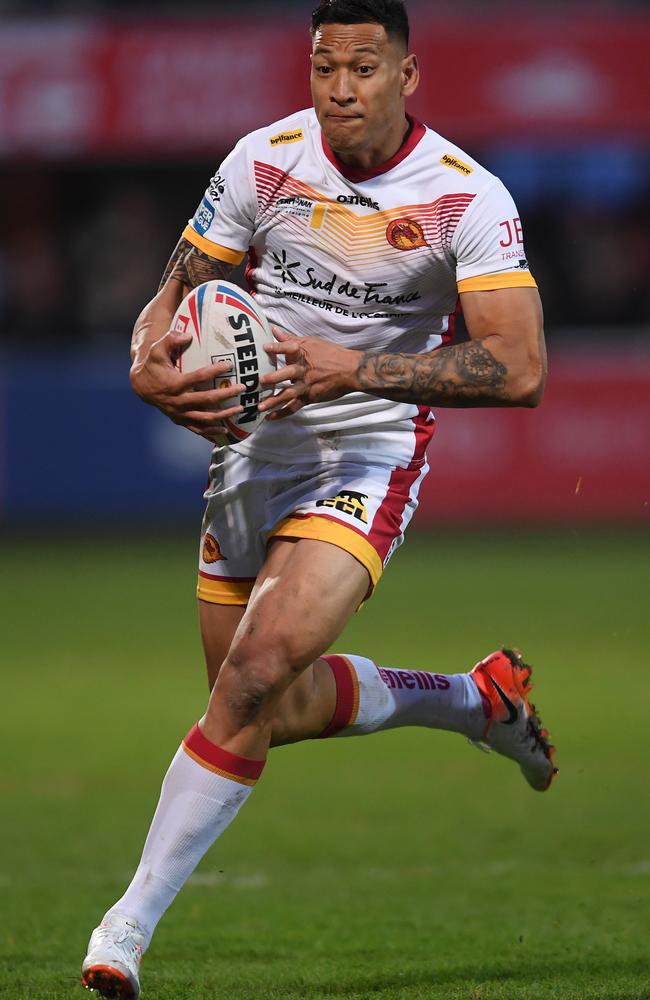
[81,914,146,1000]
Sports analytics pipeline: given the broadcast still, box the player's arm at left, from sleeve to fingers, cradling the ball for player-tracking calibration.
[130,237,243,439]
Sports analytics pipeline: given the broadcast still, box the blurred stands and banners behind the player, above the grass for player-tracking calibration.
[0,0,650,527]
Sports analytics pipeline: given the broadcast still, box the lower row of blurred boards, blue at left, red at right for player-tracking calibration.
[0,346,650,527]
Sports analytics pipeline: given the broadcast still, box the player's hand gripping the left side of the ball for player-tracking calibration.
[130,330,244,441]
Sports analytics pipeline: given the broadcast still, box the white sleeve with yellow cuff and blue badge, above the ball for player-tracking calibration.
[183,140,257,264]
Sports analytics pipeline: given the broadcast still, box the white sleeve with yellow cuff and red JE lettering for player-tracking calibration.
[451,178,537,292]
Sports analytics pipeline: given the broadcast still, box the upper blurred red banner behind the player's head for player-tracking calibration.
[0,10,650,158]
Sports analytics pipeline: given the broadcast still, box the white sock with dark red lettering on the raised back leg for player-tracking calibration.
[322,654,486,738]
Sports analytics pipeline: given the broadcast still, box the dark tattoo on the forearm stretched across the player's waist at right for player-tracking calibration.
[357,340,509,406]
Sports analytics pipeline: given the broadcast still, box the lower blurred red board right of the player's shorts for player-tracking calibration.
[416,345,650,526]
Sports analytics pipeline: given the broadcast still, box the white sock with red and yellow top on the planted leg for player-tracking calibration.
[106,725,265,946]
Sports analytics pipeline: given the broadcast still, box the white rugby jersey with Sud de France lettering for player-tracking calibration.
[183,108,535,464]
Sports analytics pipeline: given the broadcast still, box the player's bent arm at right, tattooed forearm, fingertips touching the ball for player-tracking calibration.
[260,287,546,419]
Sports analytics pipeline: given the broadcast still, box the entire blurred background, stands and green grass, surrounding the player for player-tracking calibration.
[0,0,650,1000]
